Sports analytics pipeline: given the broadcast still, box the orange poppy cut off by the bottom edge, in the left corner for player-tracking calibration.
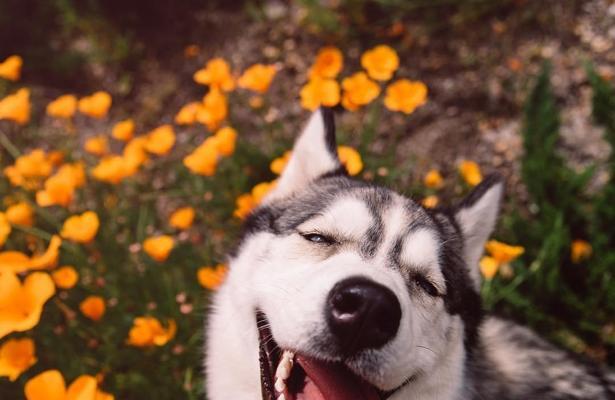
[24,370,100,400]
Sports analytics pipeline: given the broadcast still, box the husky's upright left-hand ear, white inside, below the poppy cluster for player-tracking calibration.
[266,107,344,200]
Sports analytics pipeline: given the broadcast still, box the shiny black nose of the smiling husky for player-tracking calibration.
[325,277,401,355]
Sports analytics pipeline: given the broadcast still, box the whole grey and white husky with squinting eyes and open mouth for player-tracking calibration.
[205,109,615,400]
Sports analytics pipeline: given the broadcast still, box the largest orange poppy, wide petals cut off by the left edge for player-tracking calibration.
[0,270,55,338]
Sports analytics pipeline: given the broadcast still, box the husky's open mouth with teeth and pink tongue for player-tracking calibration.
[256,311,383,400]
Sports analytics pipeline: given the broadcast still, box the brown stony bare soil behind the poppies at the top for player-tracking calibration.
[51,0,615,198]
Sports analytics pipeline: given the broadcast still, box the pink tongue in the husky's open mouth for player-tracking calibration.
[296,354,380,400]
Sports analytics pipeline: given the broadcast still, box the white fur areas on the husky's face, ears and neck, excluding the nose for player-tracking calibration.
[206,112,615,400]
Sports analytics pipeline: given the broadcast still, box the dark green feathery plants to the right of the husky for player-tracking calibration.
[486,64,615,360]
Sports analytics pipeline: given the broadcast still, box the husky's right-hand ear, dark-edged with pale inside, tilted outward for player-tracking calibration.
[455,174,504,289]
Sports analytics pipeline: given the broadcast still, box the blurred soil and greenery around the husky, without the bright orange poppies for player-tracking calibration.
[0,0,615,399]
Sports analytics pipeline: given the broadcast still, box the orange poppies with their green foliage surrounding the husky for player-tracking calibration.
[0,1,615,400]
